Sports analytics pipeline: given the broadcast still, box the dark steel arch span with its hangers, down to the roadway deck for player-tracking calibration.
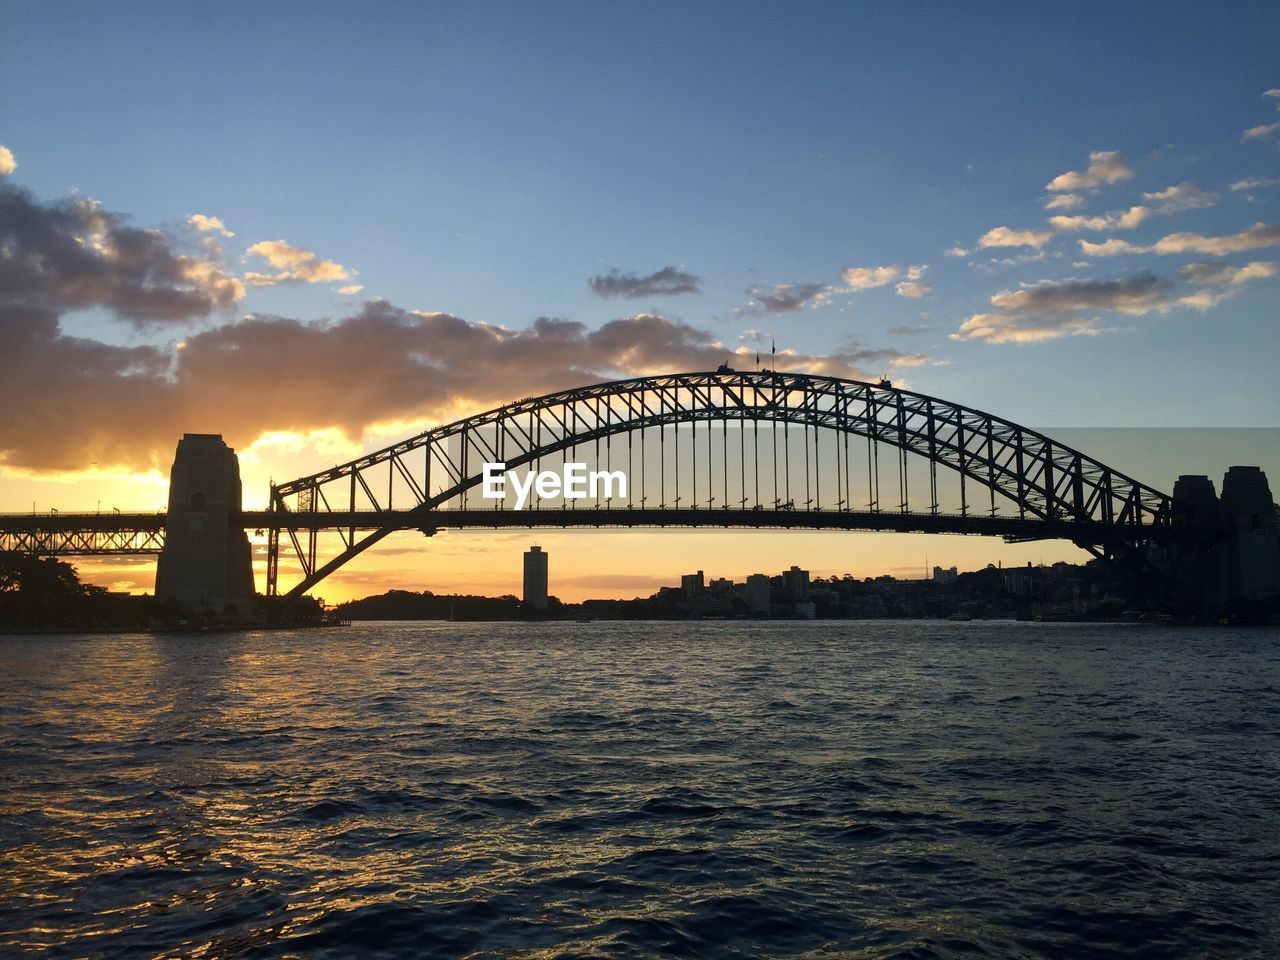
[265,367,1179,596]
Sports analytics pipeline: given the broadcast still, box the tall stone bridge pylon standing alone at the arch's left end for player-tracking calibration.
[156,434,253,623]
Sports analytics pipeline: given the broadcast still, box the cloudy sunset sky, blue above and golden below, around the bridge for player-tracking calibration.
[0,1,1280,600]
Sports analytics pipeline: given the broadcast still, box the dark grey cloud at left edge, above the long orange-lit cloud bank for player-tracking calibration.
[0,183,244,325]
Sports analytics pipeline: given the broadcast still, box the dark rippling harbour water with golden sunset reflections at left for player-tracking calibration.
[0,622,1280,957]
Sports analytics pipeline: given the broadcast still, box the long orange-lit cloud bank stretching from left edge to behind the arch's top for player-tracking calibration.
[0,301,914,471]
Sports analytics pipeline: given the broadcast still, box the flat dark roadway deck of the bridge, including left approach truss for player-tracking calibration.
[0,507,1180,556]
